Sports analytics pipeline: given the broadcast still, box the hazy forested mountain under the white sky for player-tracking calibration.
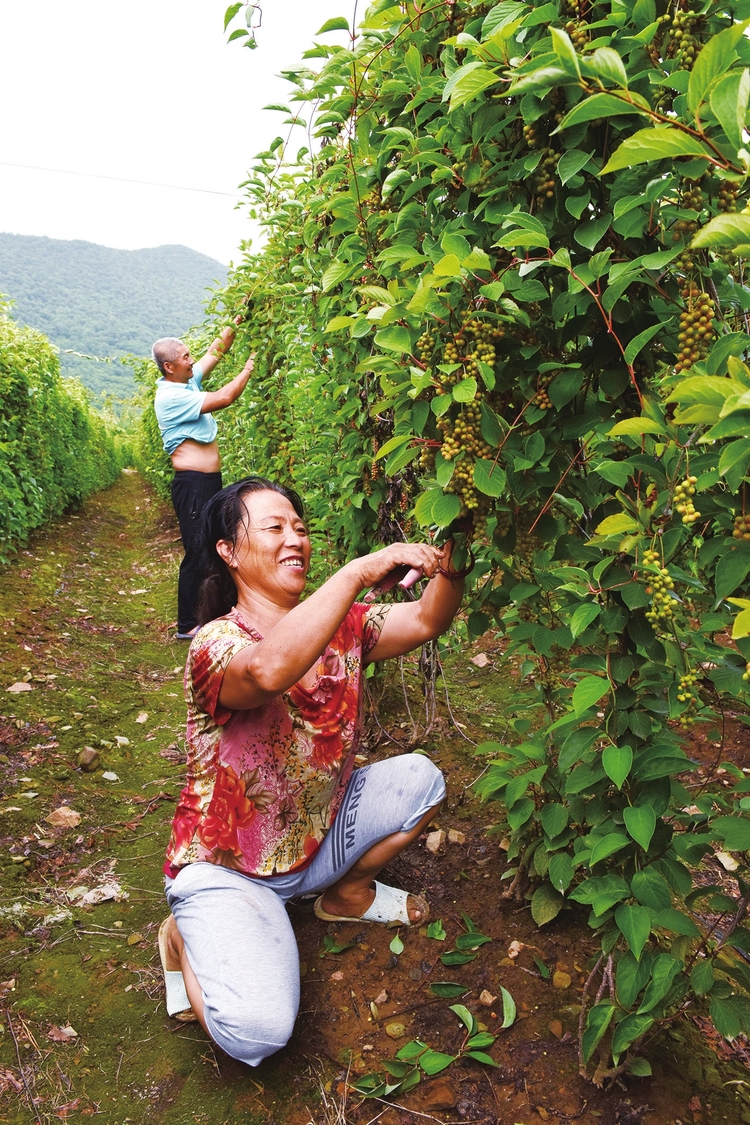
[0,234,226,395]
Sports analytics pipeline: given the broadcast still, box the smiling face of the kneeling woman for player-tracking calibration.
[226,492,311,605]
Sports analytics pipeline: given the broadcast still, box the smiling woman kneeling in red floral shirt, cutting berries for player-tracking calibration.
[160,477,462,1067]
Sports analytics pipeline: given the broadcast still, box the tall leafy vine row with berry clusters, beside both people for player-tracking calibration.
[133,0,750,1082]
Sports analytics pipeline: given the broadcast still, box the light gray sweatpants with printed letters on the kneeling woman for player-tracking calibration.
[166,754,445,1067]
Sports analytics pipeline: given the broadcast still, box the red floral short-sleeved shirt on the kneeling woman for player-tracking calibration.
[164,603,388,875]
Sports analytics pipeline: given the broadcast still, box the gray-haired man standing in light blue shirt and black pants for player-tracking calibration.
[151,316,253,640]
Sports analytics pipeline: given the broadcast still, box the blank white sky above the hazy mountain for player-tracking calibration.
[0,0,353,263]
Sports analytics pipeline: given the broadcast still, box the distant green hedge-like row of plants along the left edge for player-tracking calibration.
[0,304,130,563]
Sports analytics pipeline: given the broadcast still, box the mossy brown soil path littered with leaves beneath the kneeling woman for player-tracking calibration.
[0,473,750,1125]
